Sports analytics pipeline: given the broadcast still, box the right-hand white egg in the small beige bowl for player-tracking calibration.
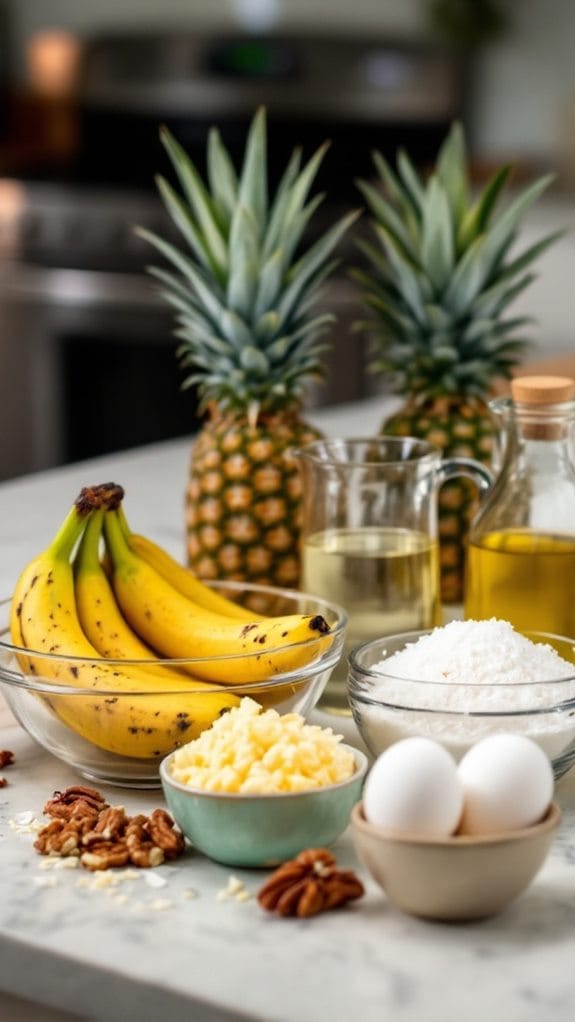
[459,734,554,834]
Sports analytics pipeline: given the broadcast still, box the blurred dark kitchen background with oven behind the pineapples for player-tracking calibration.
[0,0,575,479]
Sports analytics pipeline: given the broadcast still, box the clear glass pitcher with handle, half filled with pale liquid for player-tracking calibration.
[295,436,491,713]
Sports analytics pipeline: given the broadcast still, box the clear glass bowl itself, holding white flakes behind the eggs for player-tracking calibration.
[347,631,575,779]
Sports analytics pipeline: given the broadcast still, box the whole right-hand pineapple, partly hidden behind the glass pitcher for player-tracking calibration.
[352,123,561,603]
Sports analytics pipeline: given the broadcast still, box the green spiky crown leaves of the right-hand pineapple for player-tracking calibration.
[351,122,563,397]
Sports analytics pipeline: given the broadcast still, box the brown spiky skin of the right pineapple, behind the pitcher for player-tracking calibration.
[380,397,497,604]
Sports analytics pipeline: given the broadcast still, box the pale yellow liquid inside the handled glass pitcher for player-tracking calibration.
[302,527,440,712]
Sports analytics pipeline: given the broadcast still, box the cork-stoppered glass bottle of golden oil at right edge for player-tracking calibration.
[465,376,575,638]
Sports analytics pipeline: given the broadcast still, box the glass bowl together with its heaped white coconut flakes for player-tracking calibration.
[347,618,575,779]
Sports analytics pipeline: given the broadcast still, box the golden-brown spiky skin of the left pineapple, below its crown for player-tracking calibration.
[186,410,322,589]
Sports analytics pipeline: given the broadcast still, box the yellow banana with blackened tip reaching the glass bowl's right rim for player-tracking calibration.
[104,511,332,685]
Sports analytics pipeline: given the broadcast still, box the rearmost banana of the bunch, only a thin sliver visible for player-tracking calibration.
[118,509,263,621]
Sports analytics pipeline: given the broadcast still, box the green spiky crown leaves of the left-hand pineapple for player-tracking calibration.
[136,107,360,419]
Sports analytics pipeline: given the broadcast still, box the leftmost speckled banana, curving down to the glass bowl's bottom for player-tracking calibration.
[11,487,238,759]
